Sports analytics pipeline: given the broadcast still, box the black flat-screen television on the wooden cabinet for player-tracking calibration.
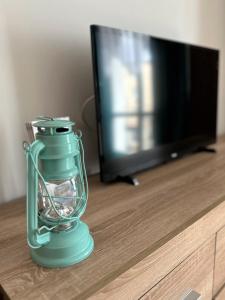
[91,25,219,181]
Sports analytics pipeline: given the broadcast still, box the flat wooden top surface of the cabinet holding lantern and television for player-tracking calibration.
[0,138,225,300]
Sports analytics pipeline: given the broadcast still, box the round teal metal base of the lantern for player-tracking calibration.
[31,221,94,268]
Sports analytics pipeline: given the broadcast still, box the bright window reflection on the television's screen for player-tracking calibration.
[103,29,154,156]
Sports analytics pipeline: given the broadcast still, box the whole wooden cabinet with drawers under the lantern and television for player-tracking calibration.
[0,137,225,300]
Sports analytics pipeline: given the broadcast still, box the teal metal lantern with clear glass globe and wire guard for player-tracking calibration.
[24,118,94,268]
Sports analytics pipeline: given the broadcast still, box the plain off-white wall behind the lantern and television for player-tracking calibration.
[0,0,225,201]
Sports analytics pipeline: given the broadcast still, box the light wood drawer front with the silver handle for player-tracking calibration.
[141,238,215,300]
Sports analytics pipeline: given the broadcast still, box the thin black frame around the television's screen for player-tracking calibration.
[90,25,220,182]
